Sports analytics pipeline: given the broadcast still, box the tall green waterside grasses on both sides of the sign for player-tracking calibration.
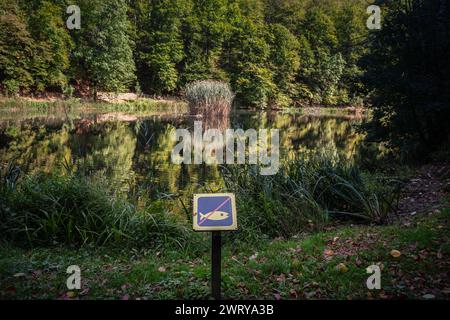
[0,156,398,248]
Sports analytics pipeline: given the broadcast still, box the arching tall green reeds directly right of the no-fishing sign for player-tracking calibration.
[223,155,398,237]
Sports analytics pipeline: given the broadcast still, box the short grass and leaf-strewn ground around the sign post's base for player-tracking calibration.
[0,164,450,300]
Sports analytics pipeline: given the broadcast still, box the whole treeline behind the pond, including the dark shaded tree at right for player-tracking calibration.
[0,0,450,155]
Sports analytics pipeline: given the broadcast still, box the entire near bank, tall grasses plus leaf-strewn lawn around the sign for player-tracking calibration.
[0,152,450,299]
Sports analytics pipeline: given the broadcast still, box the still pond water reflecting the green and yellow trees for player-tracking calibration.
[0,109,363,196]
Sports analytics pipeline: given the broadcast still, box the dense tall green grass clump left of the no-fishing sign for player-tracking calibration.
[0,168,189,247]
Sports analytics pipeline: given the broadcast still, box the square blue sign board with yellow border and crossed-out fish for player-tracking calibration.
[192,193,237,231]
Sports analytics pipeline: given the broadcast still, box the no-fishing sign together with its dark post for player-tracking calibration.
[192,193,237,300]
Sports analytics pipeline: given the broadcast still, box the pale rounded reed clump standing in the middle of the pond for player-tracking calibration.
[185,80,234,114]
